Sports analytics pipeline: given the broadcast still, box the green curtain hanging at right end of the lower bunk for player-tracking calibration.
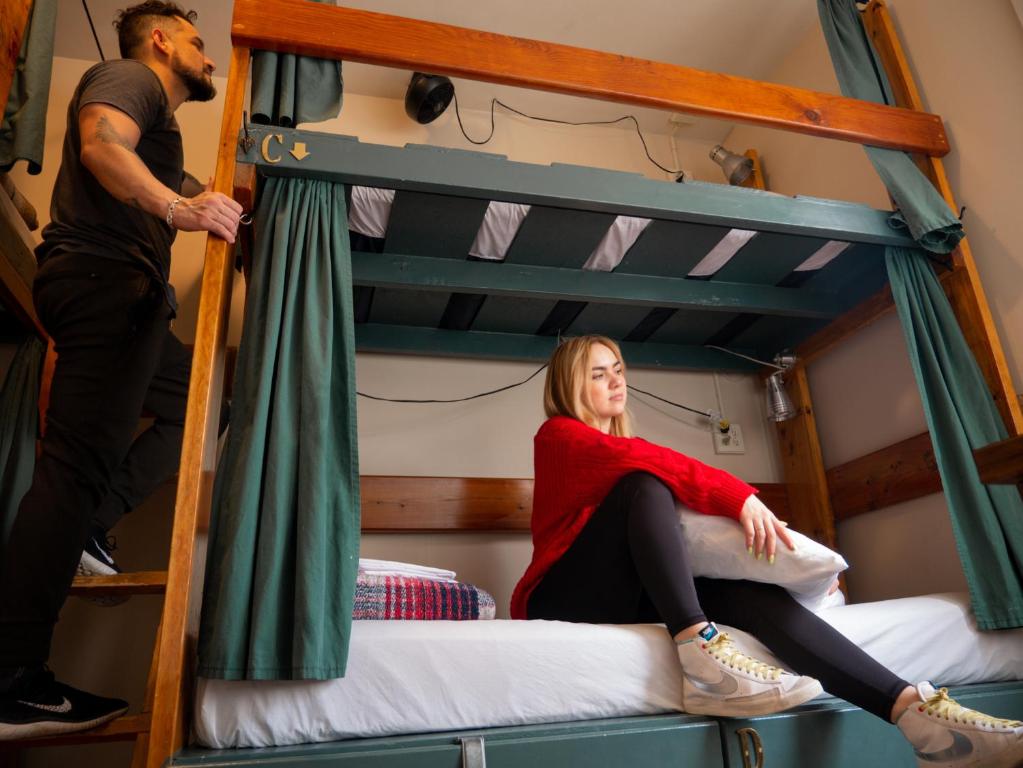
[886,247,1023,629]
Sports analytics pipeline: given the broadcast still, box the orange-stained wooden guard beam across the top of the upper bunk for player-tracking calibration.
[231,0,948,155]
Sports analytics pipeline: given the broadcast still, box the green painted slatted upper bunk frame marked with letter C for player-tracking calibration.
[237,126,913,371]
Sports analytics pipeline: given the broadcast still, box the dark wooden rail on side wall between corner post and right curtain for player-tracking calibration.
[828,432,941,521]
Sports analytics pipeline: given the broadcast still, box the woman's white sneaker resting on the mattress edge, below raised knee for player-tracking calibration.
[677,624,824,717]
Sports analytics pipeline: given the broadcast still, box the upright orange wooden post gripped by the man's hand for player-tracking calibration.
[146,47,249,768]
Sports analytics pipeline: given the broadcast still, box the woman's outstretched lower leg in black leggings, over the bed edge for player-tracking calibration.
[696,579,909,721]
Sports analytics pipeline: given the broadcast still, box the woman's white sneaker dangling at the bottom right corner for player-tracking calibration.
[897,682,1023,768]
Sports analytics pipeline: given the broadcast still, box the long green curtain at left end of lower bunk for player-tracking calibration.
[198,178,360,680]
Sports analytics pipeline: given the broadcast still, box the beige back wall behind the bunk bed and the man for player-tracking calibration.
[3,51,780,766]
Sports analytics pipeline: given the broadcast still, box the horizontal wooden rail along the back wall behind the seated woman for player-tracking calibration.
[361,475,789,533]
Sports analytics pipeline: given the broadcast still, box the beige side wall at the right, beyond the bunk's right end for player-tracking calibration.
[727,0,1023,601]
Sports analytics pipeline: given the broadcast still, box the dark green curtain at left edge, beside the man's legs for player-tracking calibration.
[0,335,46,550]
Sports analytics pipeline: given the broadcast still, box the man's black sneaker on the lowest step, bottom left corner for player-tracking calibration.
[0,669,128,741]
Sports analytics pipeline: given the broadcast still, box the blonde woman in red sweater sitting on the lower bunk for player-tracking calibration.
[512,336,1023,767]
